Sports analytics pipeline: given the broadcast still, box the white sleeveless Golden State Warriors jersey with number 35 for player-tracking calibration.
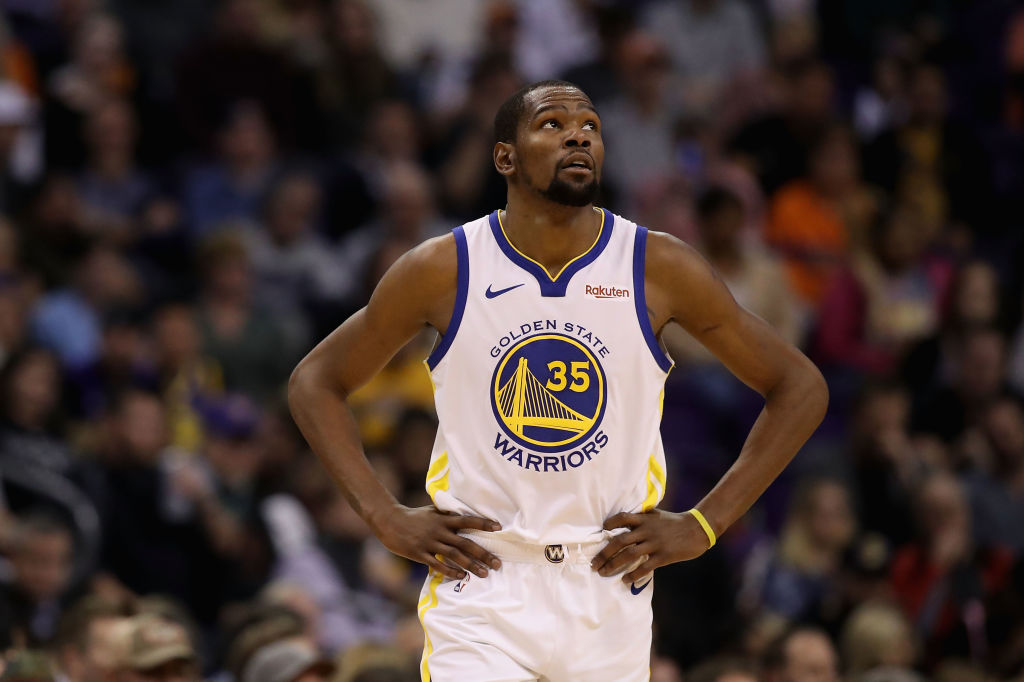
[426,209,672,545]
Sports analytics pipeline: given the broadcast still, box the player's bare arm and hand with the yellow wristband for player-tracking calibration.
[594,232,828,582]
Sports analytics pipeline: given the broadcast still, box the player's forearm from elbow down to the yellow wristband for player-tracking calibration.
[697,360,828,536]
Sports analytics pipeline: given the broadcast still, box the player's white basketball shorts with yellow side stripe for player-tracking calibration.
[419,532,653,682]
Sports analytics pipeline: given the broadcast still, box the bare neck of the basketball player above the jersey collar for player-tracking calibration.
[501,187,603,274]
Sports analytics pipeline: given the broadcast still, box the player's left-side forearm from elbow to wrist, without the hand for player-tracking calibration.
[288,371,398,532]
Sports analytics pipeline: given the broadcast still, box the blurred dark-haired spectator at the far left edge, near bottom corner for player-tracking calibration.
[0,512,75,647]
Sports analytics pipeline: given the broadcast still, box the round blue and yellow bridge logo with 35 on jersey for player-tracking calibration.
[492,334,607,450]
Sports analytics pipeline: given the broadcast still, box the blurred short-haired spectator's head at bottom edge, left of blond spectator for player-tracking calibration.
[762,627,840,682]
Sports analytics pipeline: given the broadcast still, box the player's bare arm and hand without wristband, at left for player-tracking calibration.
[288,235,498,578]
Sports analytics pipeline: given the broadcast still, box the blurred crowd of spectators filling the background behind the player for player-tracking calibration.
[0,0,1024,682]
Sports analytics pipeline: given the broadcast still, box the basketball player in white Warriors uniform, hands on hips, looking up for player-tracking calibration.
[289,81,827,682]
